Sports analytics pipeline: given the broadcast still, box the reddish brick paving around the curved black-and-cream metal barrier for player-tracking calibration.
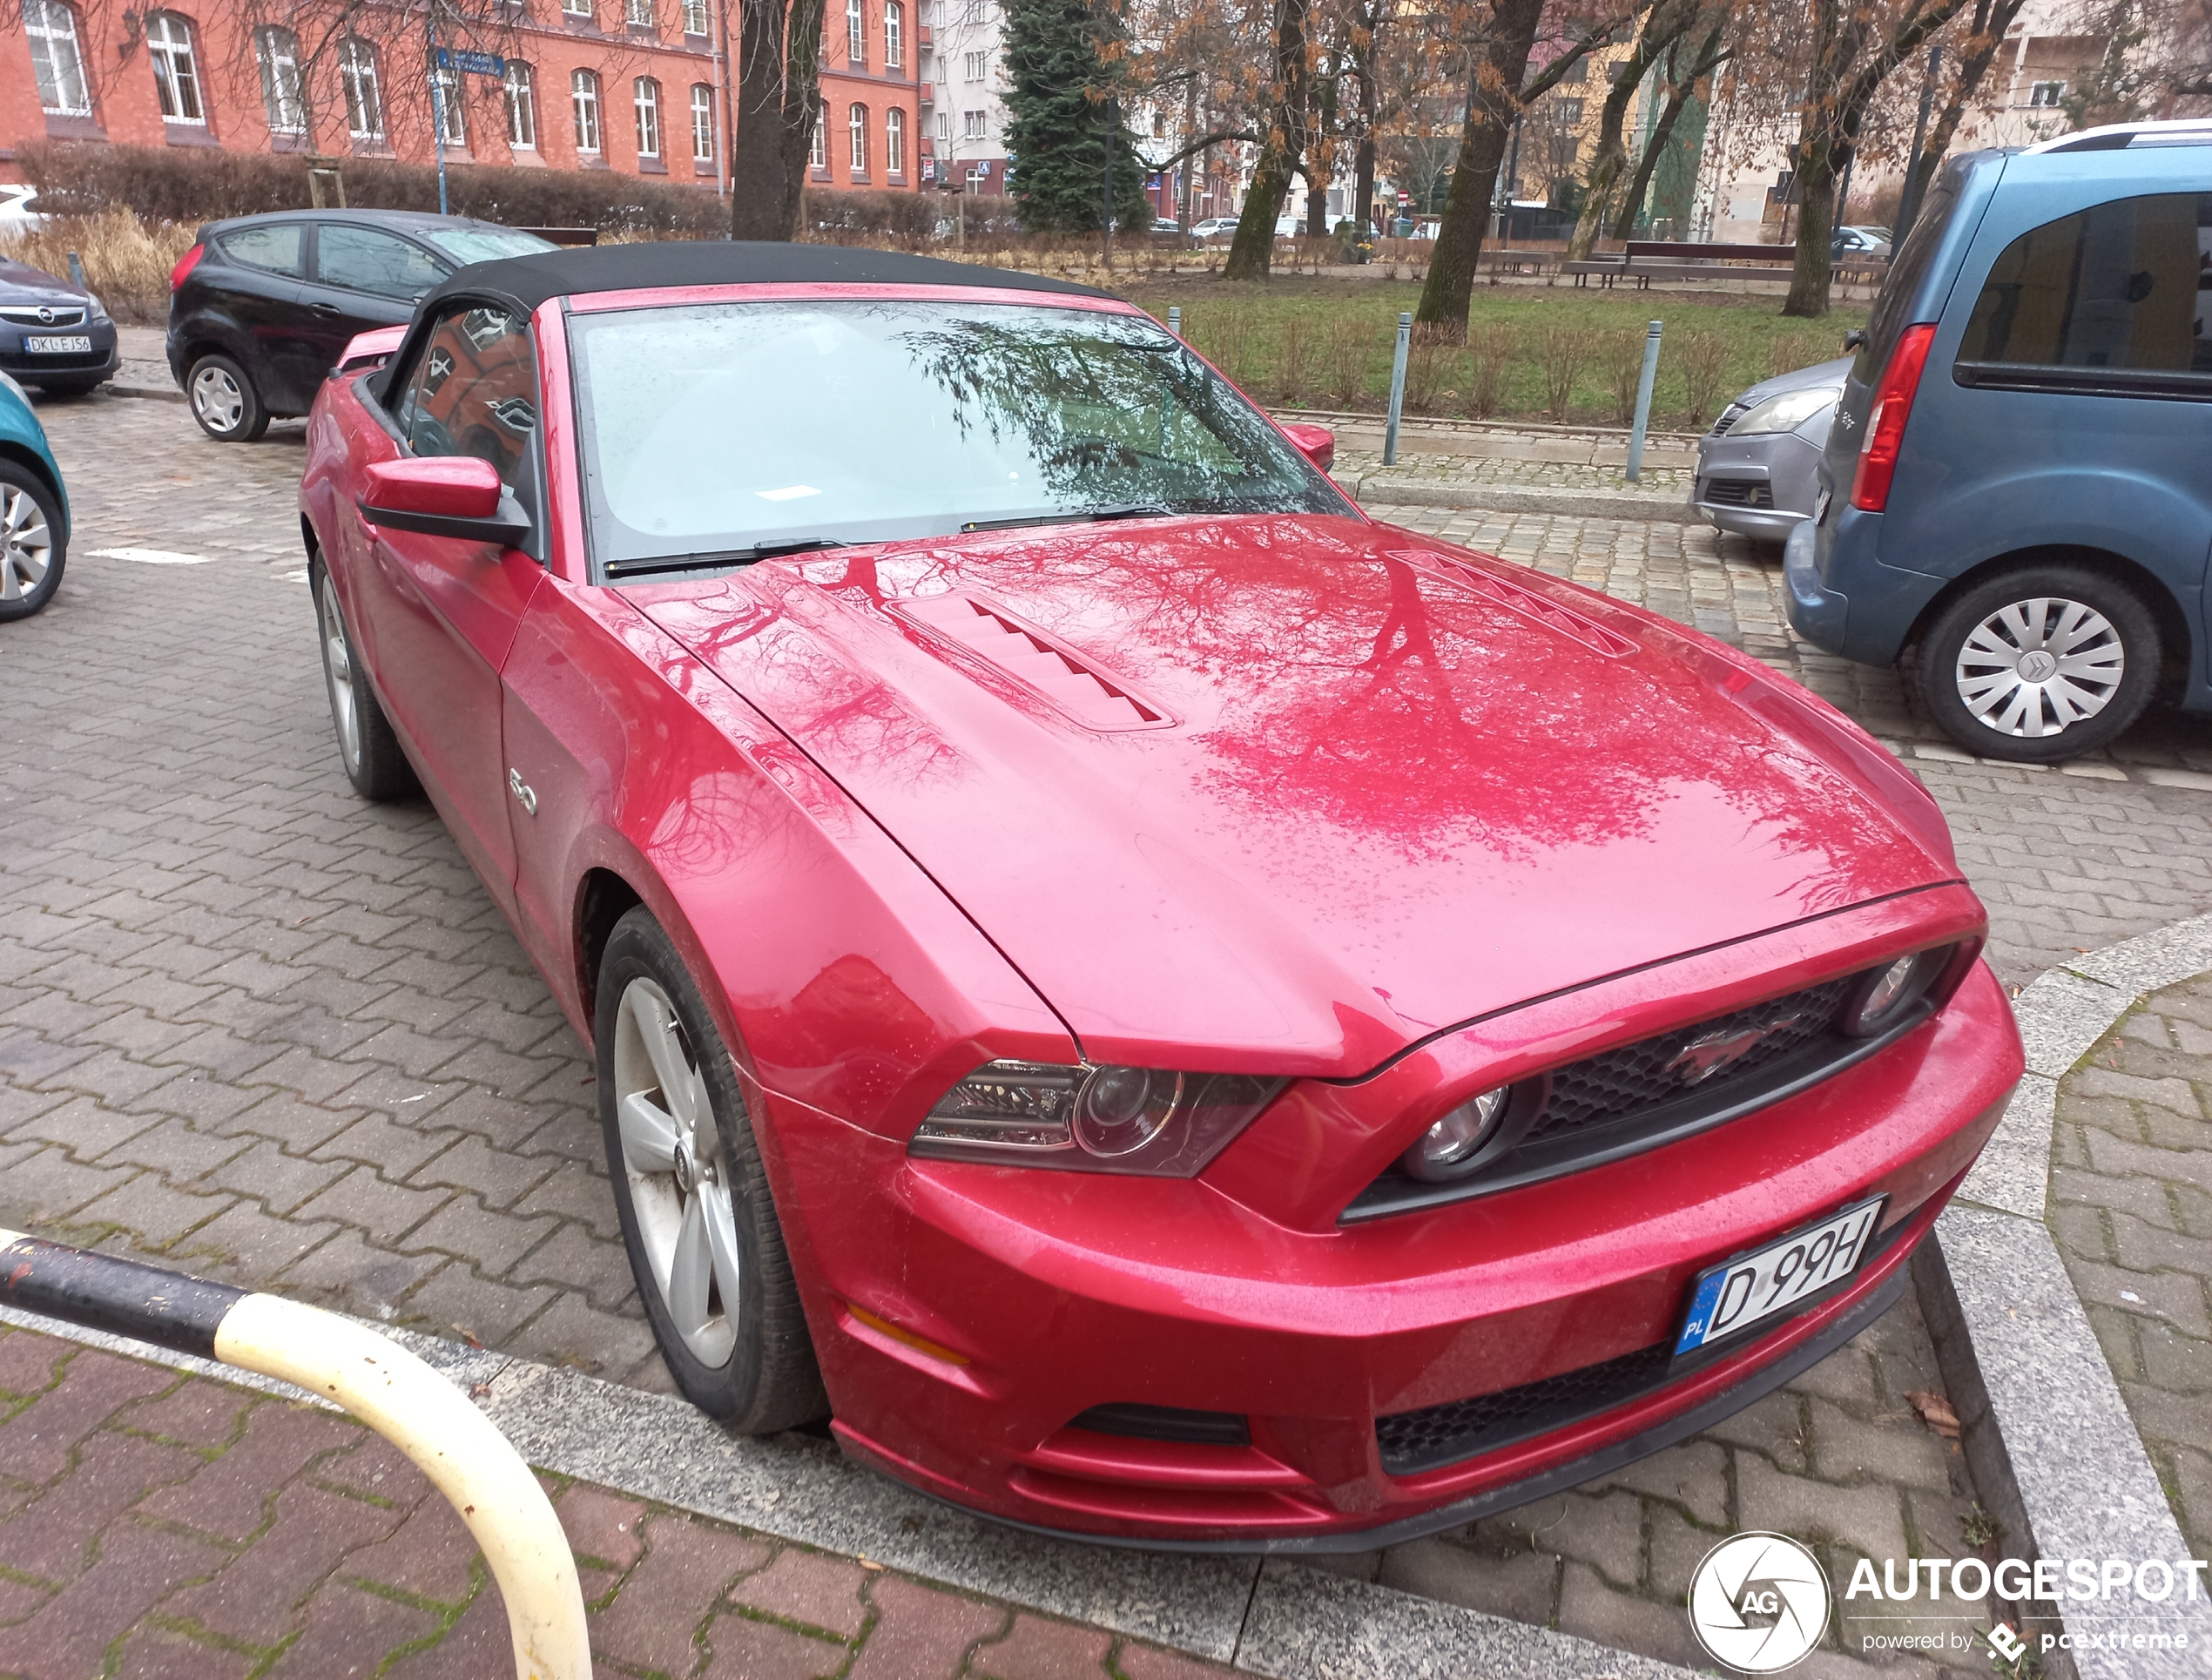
[0,1326,1228,1680]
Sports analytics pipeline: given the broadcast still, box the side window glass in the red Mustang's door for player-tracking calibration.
[394,307,537,507]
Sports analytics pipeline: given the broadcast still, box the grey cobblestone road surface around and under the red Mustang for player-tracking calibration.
[0,398,2212,1673]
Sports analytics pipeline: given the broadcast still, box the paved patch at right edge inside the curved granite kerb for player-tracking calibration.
[2051,976,2212,1558]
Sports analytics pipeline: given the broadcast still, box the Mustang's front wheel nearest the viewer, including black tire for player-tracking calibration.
[593,905,830,1434]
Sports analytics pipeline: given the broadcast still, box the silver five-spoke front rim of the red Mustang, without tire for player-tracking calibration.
[615,976,741,1368]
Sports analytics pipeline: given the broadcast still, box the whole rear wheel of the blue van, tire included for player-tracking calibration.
[1913,564,2161,764]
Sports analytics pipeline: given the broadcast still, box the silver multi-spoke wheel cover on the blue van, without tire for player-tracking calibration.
[1955,596,2128,737]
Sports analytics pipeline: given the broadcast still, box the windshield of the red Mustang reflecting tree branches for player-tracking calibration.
[569,301,1352,571]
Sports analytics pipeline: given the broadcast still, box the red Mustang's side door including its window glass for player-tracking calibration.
[356,303,544,914]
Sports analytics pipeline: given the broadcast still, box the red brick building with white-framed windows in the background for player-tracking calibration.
[0,0,927,201]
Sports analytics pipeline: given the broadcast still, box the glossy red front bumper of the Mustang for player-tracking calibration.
[763,965,2020,1552]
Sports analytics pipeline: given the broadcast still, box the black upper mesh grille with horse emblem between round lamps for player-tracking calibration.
[1524,978,1851,1146]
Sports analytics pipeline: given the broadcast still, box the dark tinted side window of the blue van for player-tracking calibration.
[1958,192,2212,372]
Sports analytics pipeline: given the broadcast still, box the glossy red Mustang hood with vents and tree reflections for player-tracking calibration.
[628,518,1958,1076]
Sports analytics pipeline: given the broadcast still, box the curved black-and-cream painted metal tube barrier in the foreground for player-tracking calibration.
[0,1231,590,1680]
